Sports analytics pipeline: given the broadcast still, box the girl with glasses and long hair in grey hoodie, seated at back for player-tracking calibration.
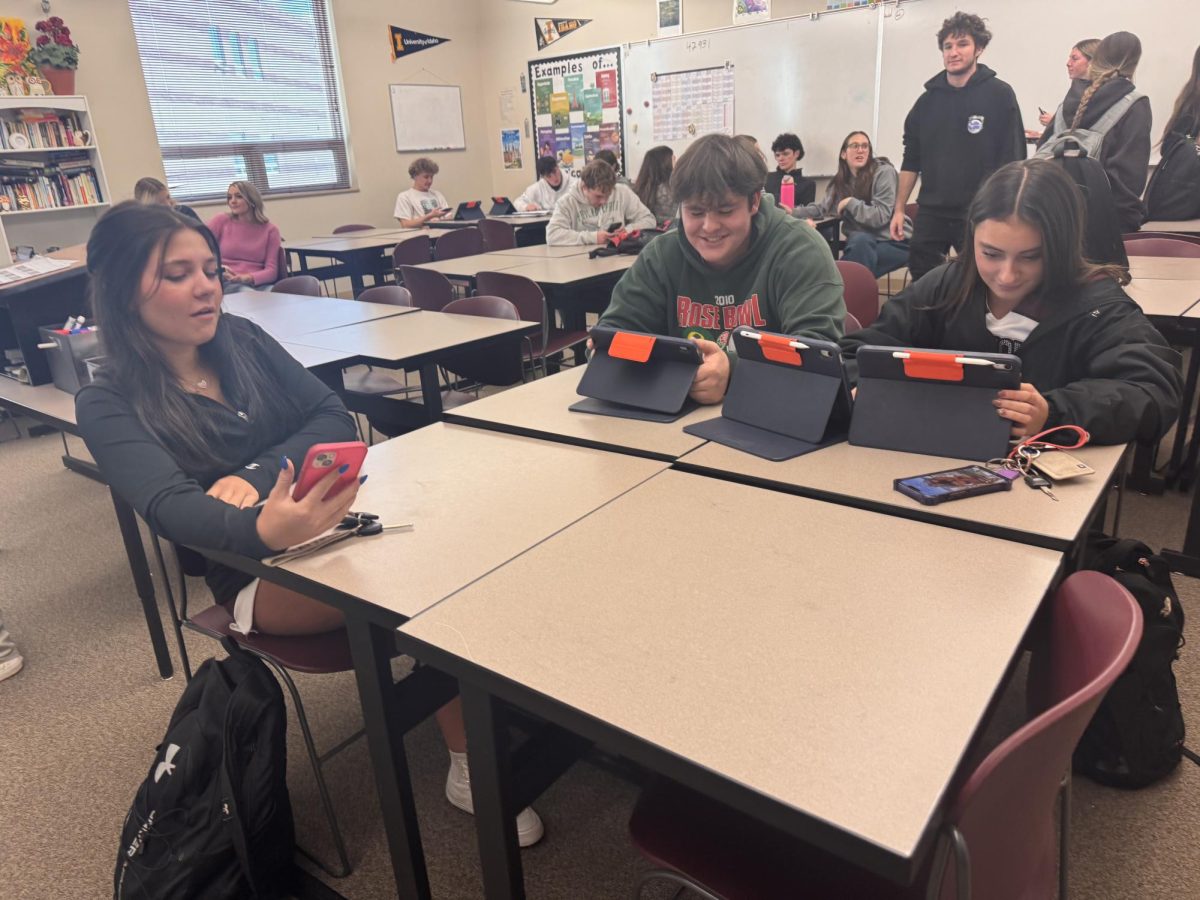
[792,131,912,278]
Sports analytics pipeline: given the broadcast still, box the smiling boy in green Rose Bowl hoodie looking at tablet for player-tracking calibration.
[600,134,846,403]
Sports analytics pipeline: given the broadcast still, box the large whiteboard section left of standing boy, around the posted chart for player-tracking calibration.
[624,8,888,178]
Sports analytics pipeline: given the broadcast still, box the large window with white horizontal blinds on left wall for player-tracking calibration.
[130,0,350,200]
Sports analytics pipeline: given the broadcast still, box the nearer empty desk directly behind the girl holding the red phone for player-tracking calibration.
[293,301,541,424]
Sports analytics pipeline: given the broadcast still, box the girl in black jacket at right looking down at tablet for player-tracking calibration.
[841,160,1182,444]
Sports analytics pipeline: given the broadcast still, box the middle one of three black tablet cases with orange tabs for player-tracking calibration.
[684,328,851,462]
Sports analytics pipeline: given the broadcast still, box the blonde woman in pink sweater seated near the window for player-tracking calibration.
[209,181,280,290]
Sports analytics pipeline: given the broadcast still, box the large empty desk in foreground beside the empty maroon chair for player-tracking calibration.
[397,472,1062,898]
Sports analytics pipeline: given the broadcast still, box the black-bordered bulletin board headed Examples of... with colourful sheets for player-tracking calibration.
[529,47,625,174]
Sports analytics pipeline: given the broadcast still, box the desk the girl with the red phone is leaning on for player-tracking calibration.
[200,424,666,898]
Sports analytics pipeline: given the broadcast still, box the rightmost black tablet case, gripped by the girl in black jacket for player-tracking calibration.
[850,346,1021,461]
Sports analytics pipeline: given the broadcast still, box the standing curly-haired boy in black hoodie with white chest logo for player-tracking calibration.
[892,12,1025,281]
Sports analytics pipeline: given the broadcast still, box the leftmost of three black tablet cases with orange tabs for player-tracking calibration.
[570,326,700,421]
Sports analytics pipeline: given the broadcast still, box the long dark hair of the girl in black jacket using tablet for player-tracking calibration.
[937,160,1129,317]
